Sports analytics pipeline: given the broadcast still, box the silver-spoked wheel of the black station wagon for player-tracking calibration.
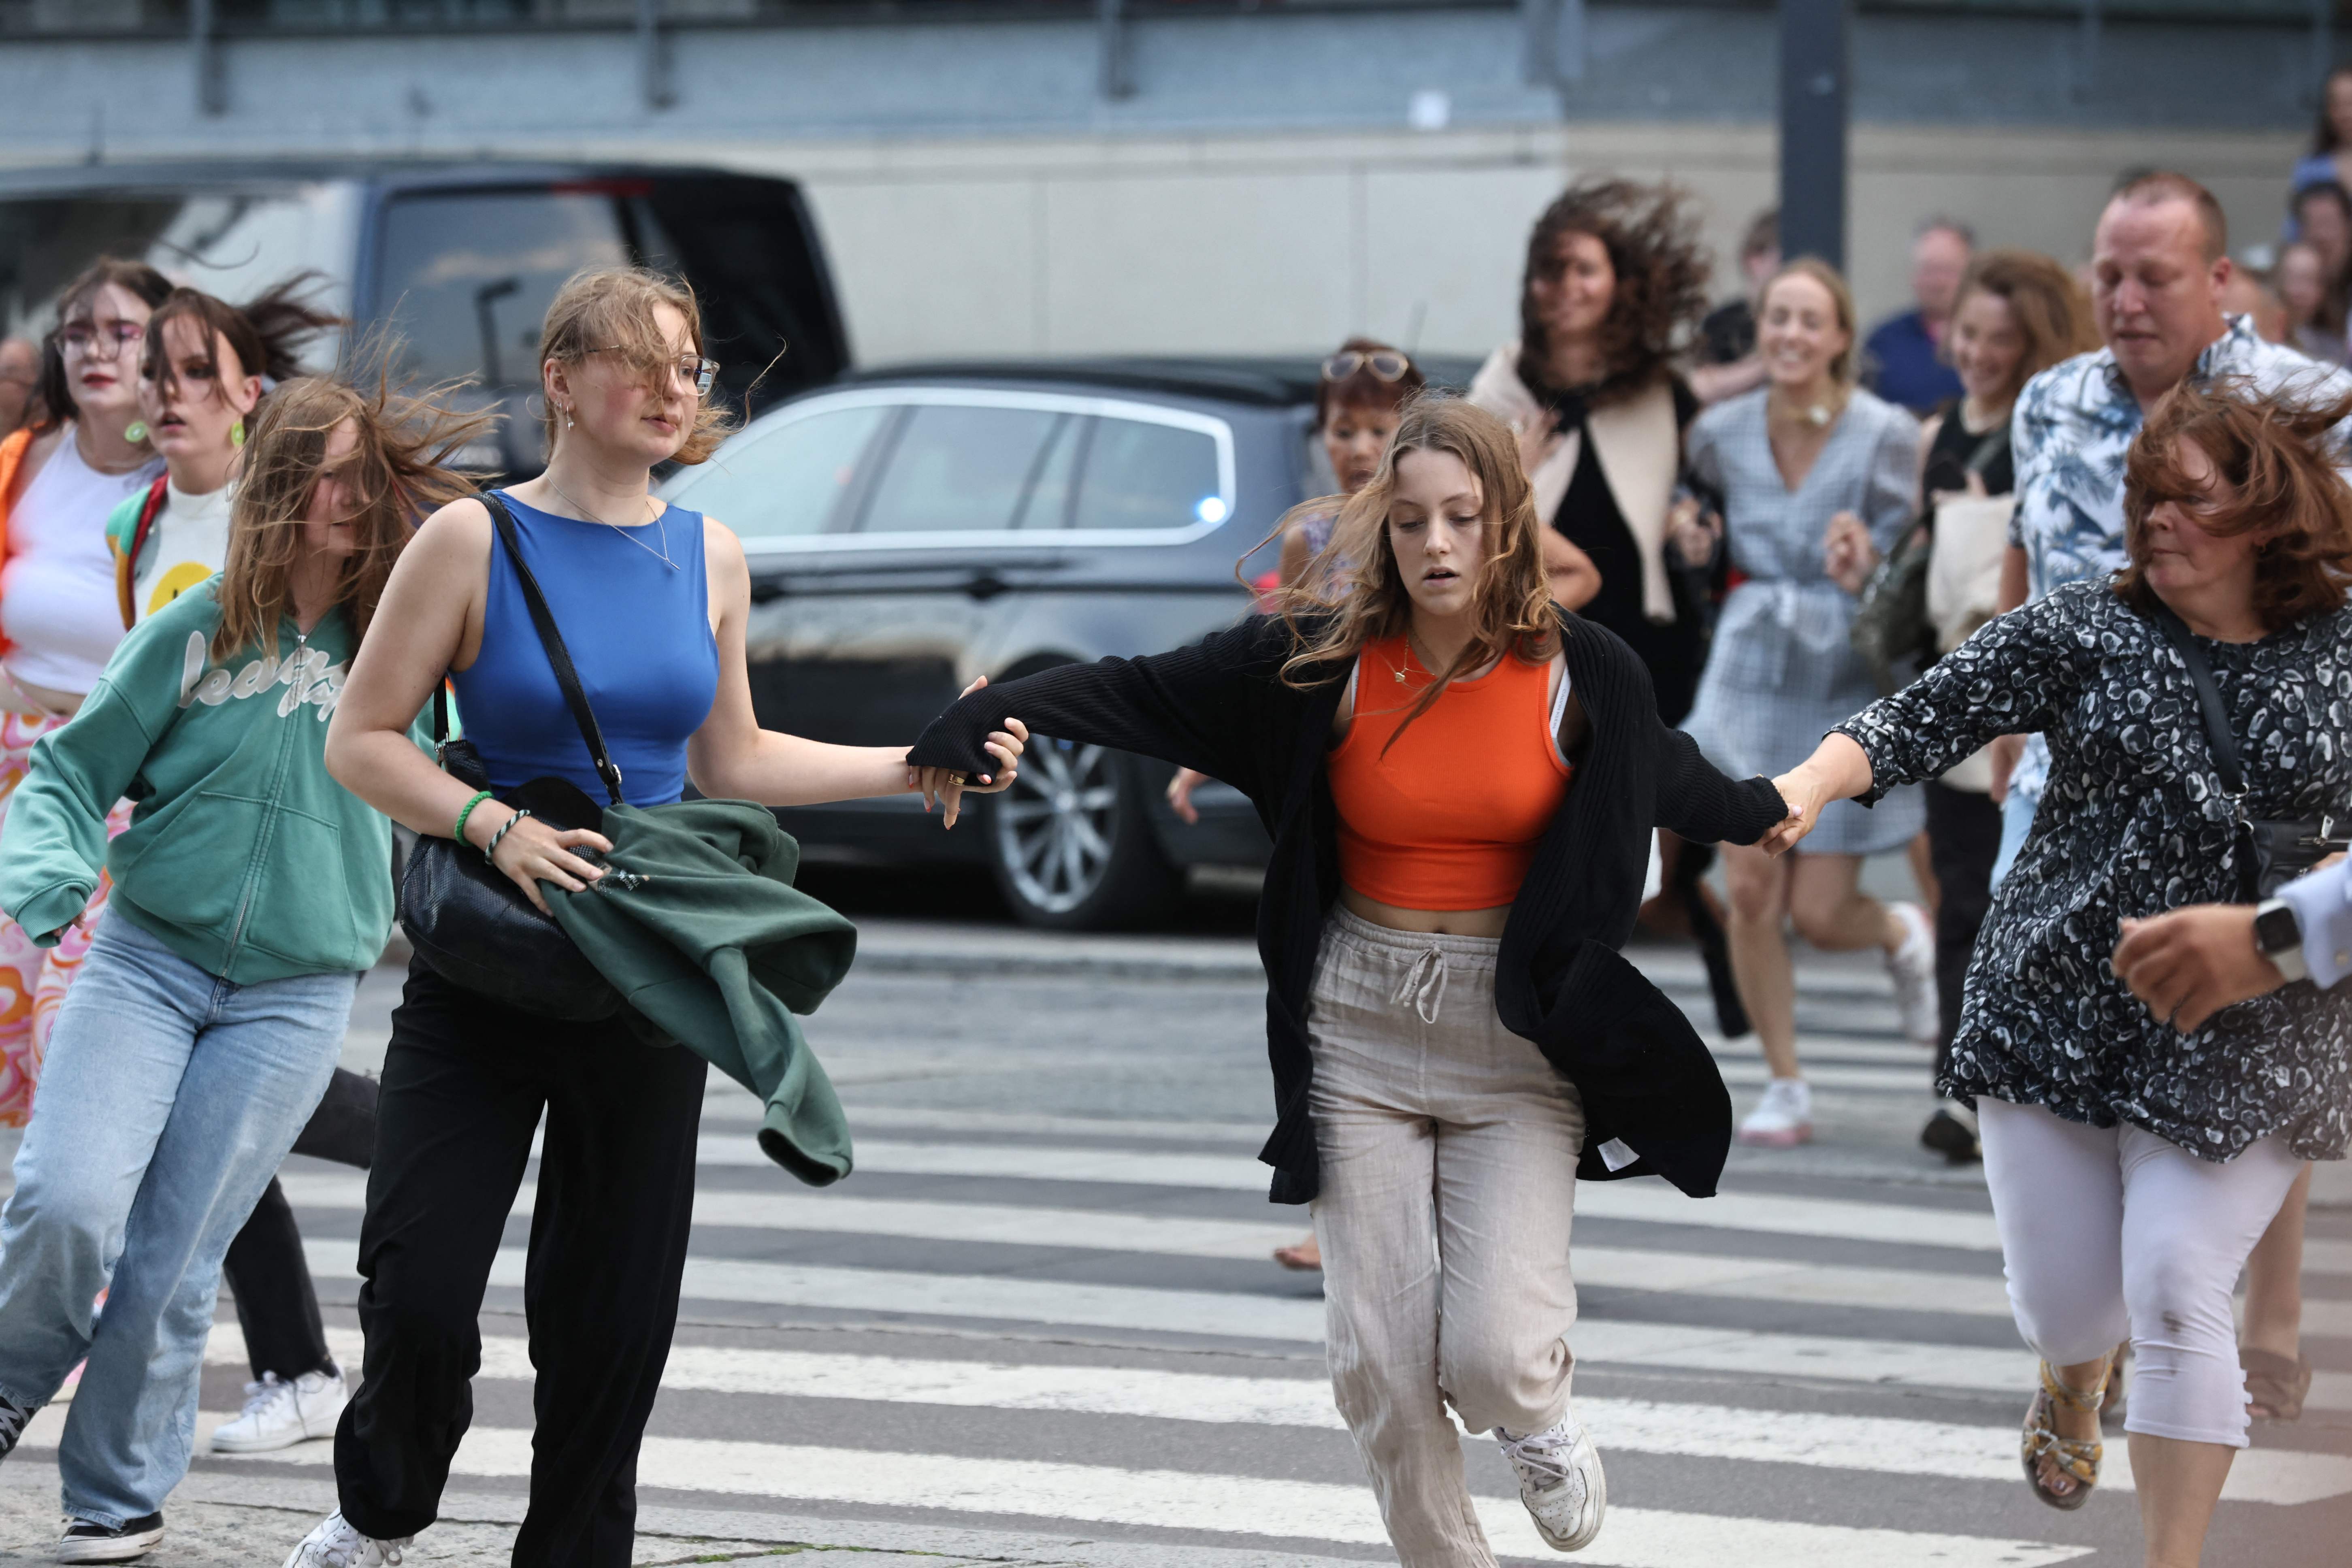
[988,736,1183,931]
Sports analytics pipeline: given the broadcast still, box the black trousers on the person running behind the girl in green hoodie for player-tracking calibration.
[221,1067,376,1382]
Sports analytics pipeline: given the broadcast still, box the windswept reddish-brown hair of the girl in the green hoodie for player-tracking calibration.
[212,374,496,660]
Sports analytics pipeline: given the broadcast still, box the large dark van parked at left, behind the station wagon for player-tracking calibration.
[0,160,849,475]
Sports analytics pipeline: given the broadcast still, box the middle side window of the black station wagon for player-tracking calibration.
[859,402,1070,534]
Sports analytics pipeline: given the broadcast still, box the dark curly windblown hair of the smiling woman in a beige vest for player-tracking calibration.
[1519,179,1712,404]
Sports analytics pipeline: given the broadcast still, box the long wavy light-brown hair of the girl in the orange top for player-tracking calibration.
[1272,392,1559,736]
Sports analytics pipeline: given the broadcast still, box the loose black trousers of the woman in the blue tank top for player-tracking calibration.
[334,964,703,1568]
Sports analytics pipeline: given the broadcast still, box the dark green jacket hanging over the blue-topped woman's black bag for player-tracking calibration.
[539,799,859,1187]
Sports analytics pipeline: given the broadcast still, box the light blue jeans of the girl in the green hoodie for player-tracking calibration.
[0,912,360,1526]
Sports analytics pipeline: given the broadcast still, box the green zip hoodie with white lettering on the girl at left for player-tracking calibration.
[0,578,393,985]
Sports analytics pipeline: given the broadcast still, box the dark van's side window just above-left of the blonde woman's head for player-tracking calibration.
[379,190,631,386]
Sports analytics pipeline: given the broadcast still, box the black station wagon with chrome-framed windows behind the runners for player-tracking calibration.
[663,360,1329,929]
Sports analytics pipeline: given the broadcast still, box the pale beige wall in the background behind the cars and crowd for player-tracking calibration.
[682,125,2296,364]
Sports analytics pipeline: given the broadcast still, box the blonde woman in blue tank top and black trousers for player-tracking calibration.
[287,271,1025,1568]
